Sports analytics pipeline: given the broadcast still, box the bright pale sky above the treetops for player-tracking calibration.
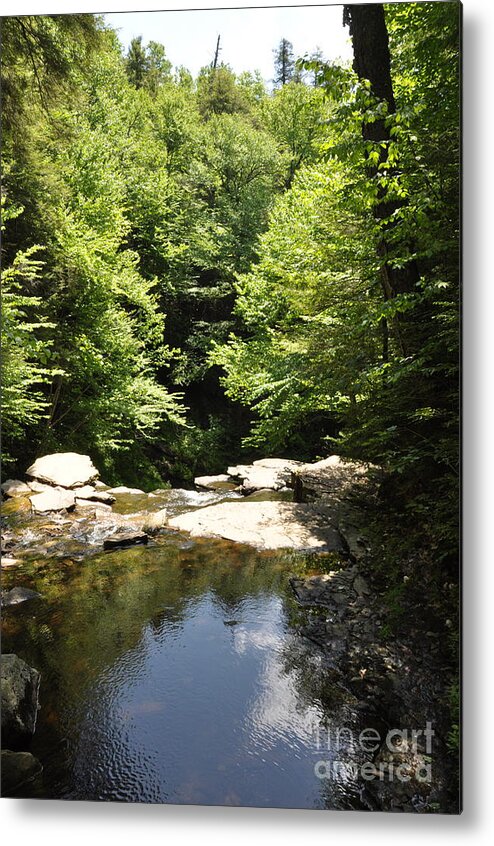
[104,0,352,83]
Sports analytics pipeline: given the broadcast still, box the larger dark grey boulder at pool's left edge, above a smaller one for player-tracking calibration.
[0,654,40,747]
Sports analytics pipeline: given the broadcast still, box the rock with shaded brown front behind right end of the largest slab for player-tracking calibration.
[291,455,369,502]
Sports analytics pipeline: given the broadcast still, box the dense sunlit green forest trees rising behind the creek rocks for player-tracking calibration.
[1,2,459,528]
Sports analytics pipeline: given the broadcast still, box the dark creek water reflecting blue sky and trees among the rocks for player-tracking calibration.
[2,491,361,809]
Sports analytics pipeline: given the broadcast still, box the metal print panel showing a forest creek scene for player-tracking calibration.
[1,2,461,814]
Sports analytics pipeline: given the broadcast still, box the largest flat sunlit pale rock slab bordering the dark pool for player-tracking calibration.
[168,502,344,552]
